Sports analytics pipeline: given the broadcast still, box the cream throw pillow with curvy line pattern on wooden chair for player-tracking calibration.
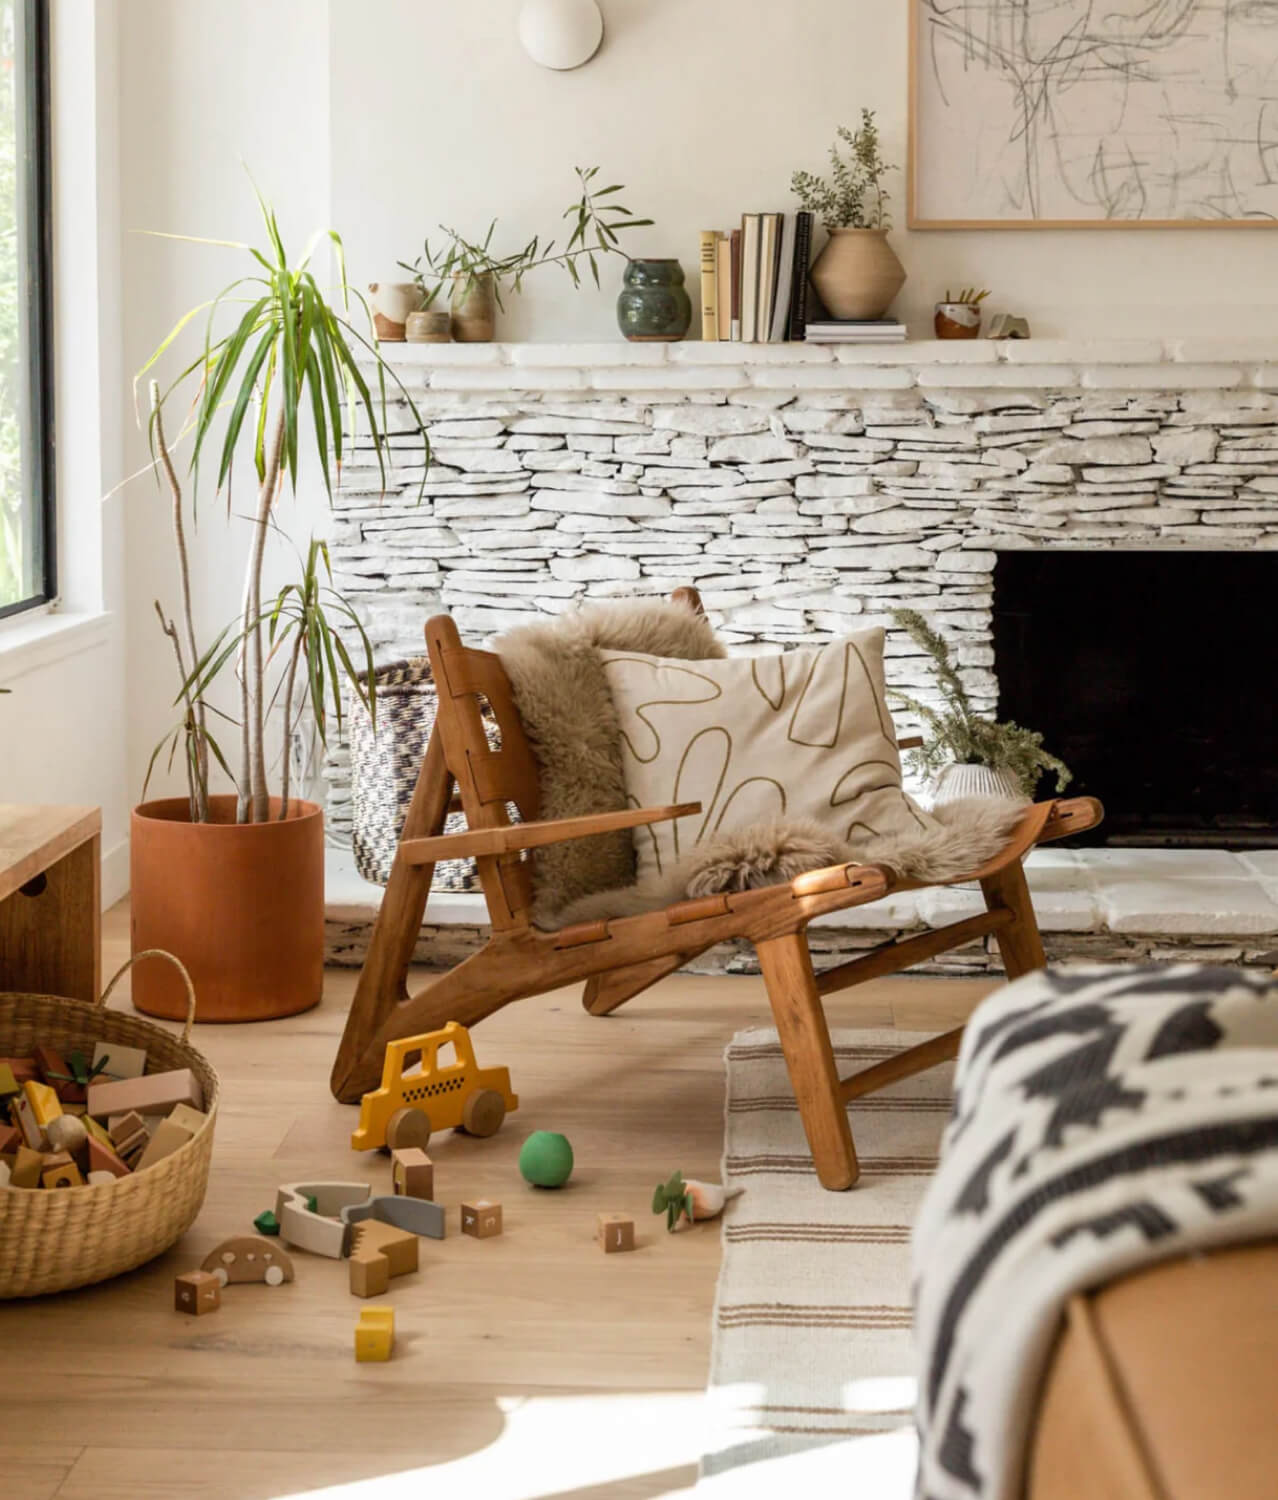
[600,630,932,881]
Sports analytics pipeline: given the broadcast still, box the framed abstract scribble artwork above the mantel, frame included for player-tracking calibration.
[906,0,1278,230]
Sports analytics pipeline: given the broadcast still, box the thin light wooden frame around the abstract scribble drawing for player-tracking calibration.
[906,0,1278,230]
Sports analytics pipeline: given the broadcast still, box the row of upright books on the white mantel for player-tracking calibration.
[701,213,812,344]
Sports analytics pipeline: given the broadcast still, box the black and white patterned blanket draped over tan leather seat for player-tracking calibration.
[914,965,1278,1500]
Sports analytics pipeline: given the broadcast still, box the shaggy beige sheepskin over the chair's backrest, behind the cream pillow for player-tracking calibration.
[494,600,725,923]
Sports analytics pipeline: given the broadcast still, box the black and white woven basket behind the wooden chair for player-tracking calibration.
[350,657,497,891]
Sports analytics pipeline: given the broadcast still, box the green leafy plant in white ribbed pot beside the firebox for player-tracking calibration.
[891,609,1073,803]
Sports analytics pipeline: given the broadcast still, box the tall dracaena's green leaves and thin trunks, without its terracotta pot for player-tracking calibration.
[138,195,429,822]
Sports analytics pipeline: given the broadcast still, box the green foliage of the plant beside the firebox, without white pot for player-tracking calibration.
[888,609,1073,797]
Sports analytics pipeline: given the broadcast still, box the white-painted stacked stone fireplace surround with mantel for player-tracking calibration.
[329,341,1278,966]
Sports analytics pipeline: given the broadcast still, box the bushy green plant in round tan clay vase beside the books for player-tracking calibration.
[791,110,905,320]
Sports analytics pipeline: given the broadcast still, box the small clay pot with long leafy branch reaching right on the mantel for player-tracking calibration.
[399,167,653,344]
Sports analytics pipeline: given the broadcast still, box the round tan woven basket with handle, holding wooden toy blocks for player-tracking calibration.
[0,948,218,1299]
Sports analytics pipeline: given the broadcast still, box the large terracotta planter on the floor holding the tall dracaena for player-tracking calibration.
[129,797,324,1022]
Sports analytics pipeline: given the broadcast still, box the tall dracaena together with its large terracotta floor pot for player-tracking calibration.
[131,187,429,1020]
